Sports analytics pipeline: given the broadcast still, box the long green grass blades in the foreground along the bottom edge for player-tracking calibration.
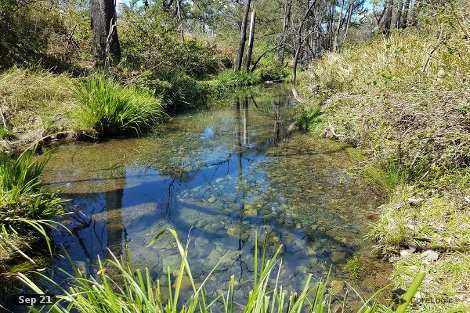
[19,229,424,313]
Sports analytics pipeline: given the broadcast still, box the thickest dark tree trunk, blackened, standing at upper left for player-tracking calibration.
[90,0,121,66]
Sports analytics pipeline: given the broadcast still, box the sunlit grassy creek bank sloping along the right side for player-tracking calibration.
[297,21,470,312]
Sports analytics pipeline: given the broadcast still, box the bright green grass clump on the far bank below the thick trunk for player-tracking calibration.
[76,74,165,136]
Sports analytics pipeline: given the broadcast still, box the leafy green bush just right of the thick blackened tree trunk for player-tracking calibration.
[119,3,223,79]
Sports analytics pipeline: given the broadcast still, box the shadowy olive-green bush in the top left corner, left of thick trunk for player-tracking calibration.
[0,0,91,71]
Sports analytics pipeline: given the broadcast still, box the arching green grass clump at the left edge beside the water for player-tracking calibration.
[0,149,63,263]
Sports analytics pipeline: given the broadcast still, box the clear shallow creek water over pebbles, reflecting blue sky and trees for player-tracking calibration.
[45,87,390,300]
